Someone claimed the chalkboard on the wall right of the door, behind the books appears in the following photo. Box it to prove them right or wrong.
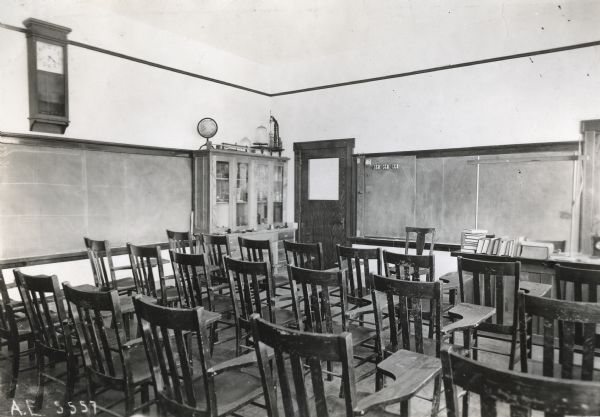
[356,146,578,245]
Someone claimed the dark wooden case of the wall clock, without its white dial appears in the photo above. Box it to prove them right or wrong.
[23,18,71,134]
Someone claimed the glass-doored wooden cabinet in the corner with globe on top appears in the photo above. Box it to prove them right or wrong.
[193,149,294,270]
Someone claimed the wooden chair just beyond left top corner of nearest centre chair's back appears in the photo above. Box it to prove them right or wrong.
[225,256,295,356]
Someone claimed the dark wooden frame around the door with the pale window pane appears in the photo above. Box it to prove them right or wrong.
[294,138,356,242]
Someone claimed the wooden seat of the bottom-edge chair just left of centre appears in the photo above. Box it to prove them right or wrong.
[188,365,263,416]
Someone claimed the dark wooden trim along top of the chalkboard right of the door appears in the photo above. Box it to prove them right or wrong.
[354,141,581,158]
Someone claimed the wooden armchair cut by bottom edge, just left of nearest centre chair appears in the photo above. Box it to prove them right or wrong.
[133,296,262,417]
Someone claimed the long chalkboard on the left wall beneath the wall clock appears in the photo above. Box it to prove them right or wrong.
[0,144,192,259]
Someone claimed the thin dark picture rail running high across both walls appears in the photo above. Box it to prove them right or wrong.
[0,22,600,97]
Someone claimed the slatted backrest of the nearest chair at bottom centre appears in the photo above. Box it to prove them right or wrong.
[252,315,356,417]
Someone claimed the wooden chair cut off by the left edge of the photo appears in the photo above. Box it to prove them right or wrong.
[0,270,34,398]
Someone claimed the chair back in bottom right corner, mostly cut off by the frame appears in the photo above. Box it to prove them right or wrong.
[441,349,600,417]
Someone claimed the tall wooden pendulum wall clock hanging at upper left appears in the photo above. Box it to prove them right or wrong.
[23,19,71,134]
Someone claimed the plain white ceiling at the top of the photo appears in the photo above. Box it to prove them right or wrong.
[85,0,600,65]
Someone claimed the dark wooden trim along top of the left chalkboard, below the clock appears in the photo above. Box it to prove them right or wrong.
[0,131,193,158]
